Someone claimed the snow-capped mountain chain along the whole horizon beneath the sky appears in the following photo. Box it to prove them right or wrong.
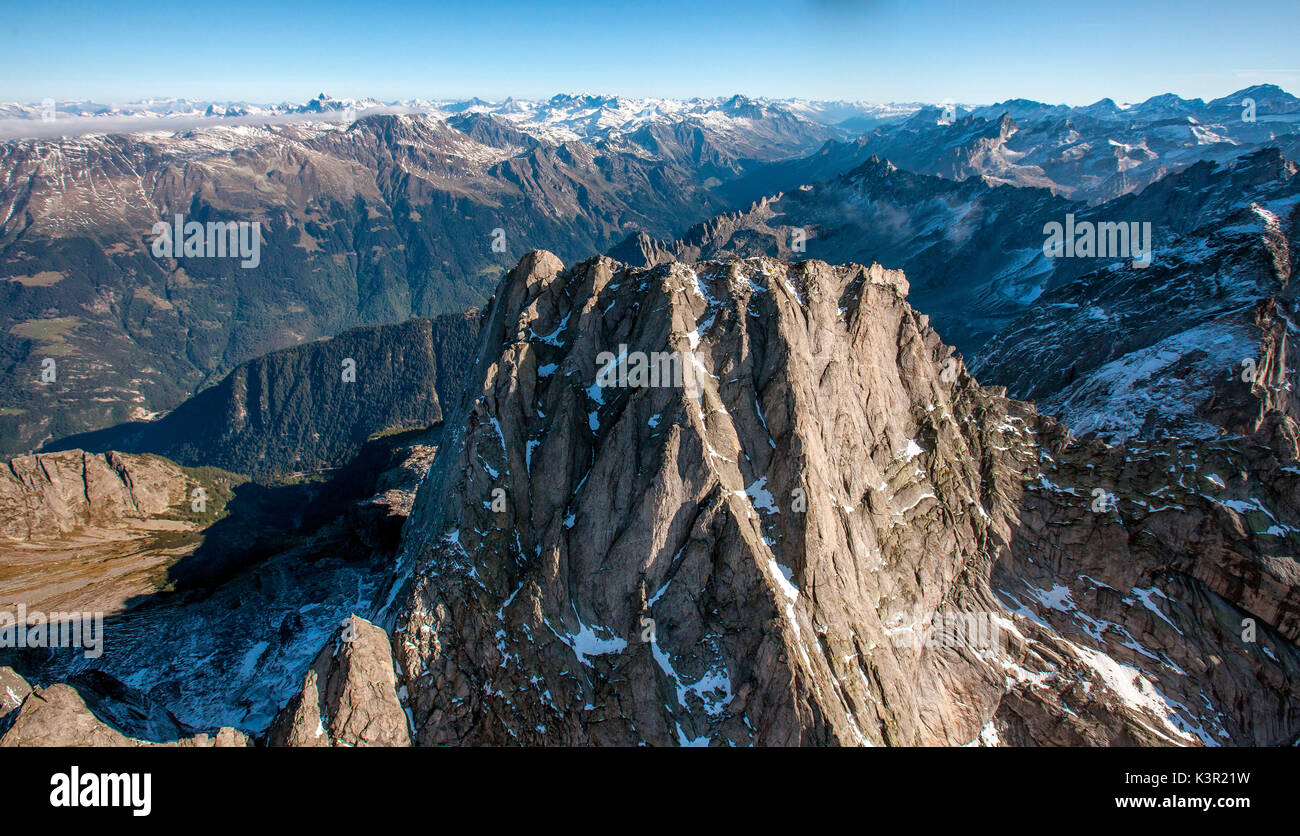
[10,85,1300,205]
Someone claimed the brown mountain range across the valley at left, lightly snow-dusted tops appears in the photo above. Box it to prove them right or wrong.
[0,107,790,452]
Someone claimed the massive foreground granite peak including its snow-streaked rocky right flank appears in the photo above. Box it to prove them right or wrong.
[369,252,1300,745]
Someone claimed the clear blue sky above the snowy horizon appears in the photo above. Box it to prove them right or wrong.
[0,0,1300,104]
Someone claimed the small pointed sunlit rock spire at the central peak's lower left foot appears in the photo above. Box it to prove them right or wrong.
[269,615,411,746]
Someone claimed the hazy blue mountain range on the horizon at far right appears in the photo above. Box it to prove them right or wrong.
[725,85,1300,204]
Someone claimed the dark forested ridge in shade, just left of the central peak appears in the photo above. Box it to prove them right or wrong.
[55,313,478,480]
